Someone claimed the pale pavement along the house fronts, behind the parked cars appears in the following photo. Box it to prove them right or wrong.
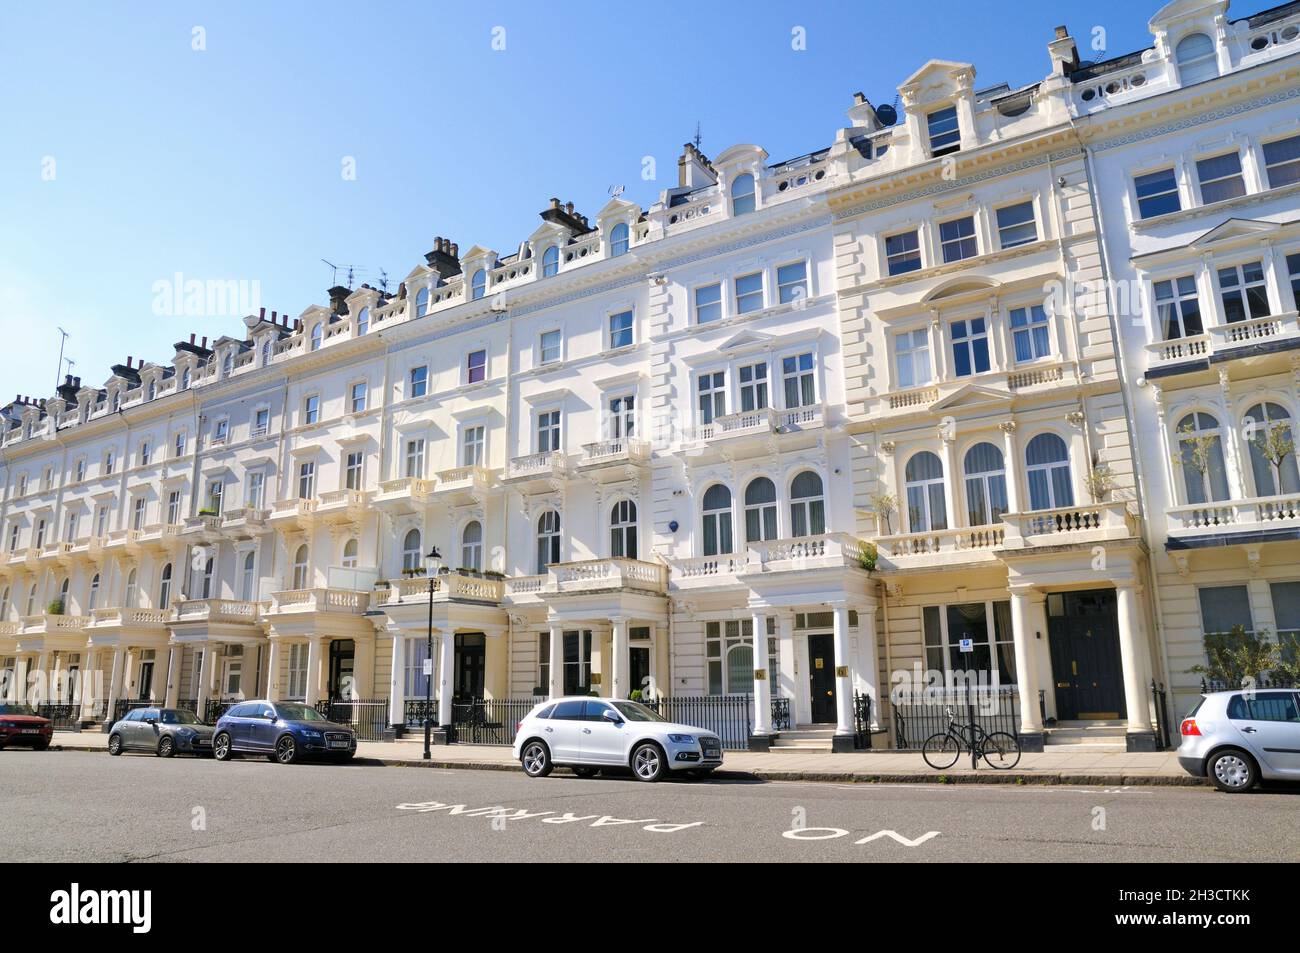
[53,732,1208,787]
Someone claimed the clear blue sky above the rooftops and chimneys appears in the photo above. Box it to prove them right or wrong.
[0,0,1232,402]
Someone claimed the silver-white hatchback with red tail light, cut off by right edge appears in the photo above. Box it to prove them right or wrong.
[1178,689,1300,794]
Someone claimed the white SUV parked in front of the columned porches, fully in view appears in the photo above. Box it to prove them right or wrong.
[515,698,723,781]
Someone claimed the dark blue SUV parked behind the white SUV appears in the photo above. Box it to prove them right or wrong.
[212,701,356,764]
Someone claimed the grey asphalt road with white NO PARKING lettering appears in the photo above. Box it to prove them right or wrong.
[0,750,1300,863]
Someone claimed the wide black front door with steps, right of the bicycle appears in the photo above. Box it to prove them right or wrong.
[1048,589,1126,720]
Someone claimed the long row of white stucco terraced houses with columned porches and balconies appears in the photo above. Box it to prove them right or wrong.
[0,0,1300,750]
